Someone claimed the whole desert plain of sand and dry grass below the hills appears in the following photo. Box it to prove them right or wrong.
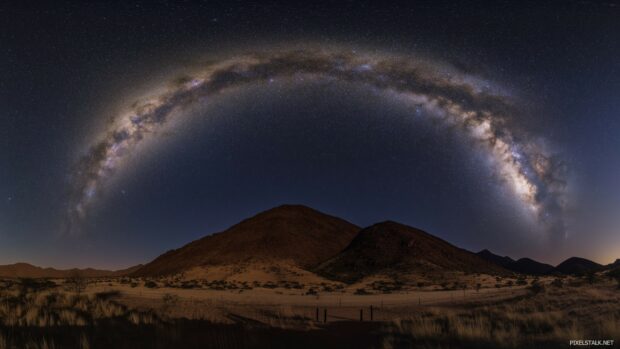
[0,273,620,349]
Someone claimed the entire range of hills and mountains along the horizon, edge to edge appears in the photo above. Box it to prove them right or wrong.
[0,201,608,283]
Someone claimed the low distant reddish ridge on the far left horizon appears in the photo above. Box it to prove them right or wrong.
[0,263,140,278]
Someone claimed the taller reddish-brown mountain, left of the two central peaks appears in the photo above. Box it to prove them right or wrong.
[133,205,360,276]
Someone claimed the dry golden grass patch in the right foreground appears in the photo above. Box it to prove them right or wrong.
[384,287,620,348]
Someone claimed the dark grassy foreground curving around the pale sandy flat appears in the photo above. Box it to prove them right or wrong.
[0,273,620,349]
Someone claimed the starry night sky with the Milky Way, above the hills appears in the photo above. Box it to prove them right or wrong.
[0,1,620,268]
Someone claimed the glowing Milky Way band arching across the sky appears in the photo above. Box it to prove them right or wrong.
[66,50,565,232]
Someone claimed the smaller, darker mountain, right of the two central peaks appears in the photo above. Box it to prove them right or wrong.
[315,221,505,282]
